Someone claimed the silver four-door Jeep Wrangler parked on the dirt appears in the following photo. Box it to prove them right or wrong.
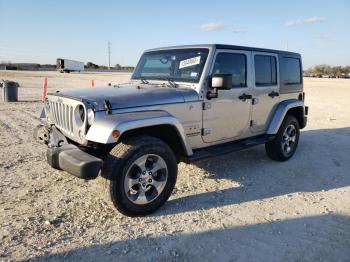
[34,45,308,216]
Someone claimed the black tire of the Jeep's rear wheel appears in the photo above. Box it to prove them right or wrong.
[265,115,300,162]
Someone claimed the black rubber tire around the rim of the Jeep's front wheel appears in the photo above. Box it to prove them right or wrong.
[102,136,177,217]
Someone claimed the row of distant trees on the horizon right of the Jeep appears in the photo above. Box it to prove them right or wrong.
[304,65,350,78]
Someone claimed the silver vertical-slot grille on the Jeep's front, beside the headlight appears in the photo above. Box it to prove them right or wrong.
[49,100,73,135]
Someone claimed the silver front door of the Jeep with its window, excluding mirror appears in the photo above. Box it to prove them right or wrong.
[202,50,252,143]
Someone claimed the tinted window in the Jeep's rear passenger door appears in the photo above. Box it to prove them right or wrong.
[254,55,277,86]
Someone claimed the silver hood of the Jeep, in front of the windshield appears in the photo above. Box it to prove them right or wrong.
[52,85,199,110]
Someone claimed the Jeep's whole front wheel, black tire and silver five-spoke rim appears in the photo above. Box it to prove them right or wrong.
[102,136,177,216]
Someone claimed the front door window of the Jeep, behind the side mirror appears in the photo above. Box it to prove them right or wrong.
[213,53,247,87]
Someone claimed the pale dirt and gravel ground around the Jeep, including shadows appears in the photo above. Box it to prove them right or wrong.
[0,71,350,261]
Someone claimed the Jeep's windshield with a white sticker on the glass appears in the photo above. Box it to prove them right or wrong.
[132,48,209,83]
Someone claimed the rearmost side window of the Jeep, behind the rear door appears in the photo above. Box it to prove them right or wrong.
[281,57,301,85]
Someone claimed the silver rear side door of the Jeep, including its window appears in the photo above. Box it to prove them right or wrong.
[250,52,279,133]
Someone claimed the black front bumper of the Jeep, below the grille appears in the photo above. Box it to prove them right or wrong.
[46,144,103,179]
